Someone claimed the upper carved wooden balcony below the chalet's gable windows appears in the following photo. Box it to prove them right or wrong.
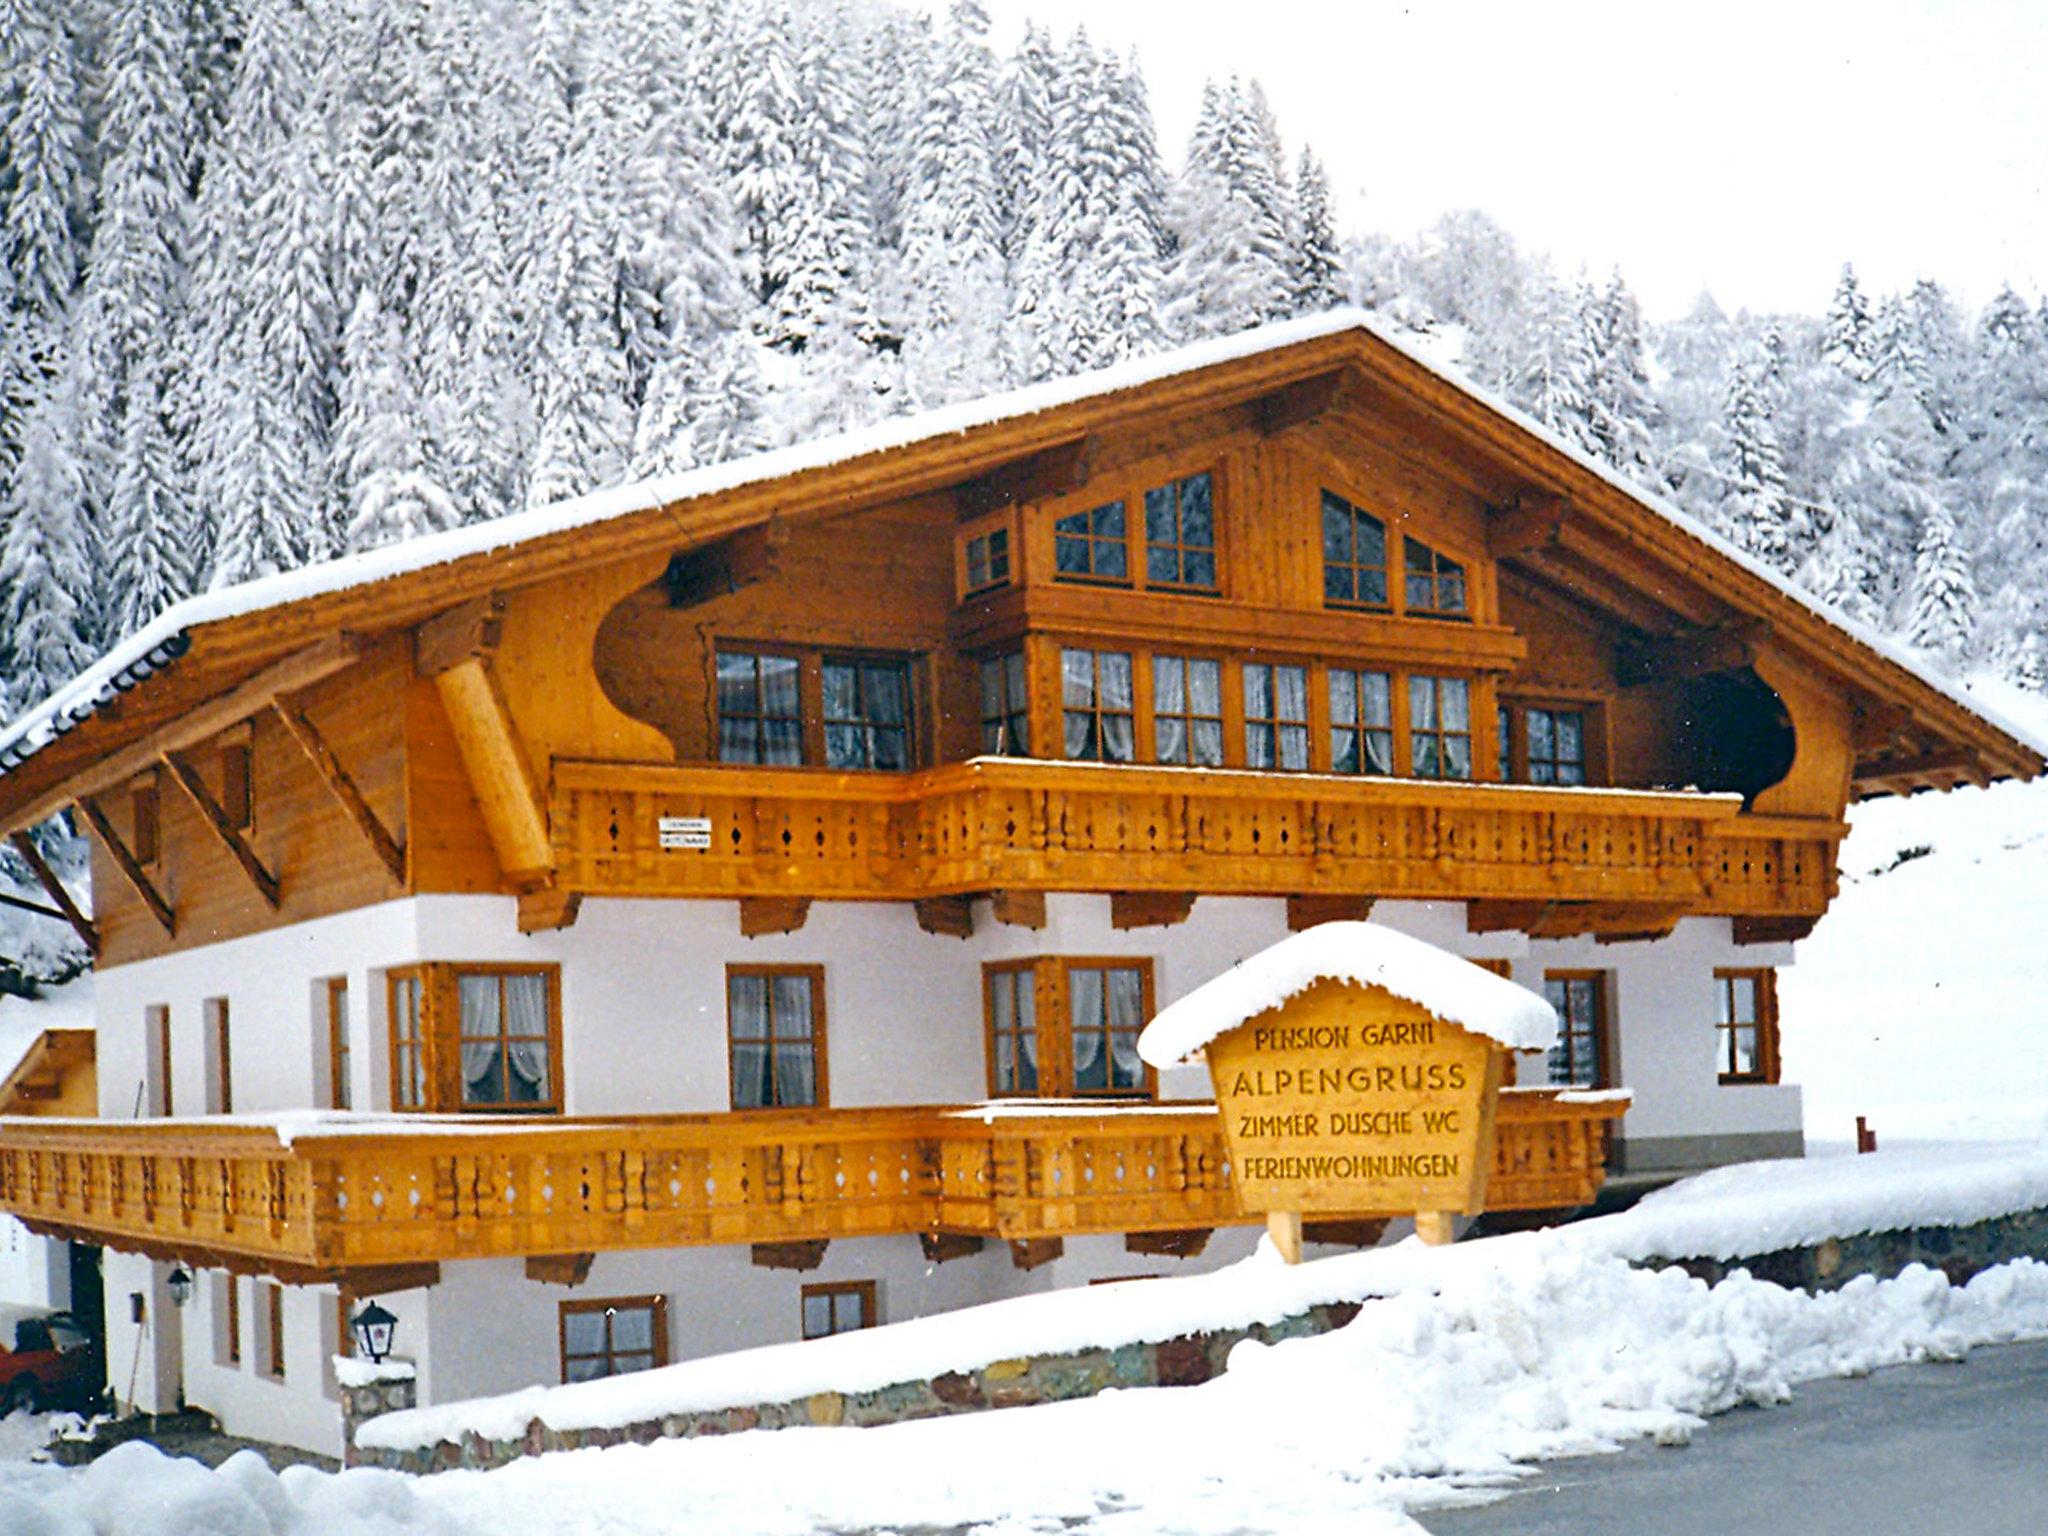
[549,758,1845,915]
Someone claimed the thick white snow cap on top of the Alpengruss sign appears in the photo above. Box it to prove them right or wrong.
[1139,922,1556,1067]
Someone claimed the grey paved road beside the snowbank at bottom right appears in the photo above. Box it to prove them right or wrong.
[1417,1343,2048,1536]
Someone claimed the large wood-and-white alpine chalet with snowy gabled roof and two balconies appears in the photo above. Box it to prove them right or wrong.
[0,315,2042,1452]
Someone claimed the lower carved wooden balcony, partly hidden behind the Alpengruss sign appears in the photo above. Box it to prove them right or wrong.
[0,1090,1628,1282]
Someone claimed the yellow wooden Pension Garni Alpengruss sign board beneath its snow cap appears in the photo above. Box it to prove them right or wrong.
[1208,981,1503,1249]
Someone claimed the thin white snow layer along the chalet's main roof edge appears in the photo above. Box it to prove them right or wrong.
[0,309,2048,794]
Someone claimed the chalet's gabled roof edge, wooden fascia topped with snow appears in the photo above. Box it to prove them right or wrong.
[0,309,2048,843]
